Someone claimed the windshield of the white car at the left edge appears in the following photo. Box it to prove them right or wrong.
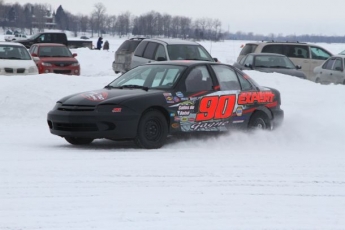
[0,45,31,60]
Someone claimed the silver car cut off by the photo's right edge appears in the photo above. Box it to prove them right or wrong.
[312,54,345,85]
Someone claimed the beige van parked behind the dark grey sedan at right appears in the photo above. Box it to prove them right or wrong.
[237,41,333,80]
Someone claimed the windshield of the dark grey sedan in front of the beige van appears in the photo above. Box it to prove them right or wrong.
[254,55,296,69]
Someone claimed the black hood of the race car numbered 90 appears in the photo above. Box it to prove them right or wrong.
[59,88,165,106]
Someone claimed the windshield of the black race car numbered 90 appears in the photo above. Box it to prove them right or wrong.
[107,64,186,89]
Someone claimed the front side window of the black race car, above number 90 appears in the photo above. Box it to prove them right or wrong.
[185,66,213,92]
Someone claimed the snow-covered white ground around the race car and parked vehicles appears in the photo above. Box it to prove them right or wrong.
[0,36,345,230]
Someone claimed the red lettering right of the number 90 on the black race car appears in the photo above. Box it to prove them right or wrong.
[237,91,274,105]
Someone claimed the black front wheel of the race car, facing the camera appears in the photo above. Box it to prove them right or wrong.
[134,110,168,149]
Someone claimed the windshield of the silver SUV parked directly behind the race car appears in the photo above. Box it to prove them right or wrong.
[167,44,214,61]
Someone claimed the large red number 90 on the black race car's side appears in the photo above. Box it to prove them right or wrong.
[195,94,236,121]
